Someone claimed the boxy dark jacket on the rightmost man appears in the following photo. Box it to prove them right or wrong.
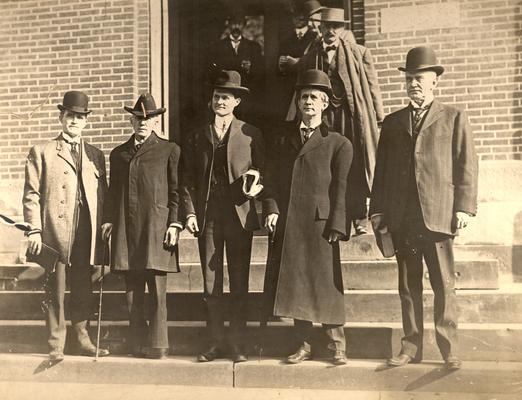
[370,100,478,235]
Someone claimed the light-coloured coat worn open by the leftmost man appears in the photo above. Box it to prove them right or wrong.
[23,135,107,265]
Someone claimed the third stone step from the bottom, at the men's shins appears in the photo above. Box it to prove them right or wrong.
[0,284,522,323]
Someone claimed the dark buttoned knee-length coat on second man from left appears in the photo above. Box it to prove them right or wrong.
[104,132,180,272]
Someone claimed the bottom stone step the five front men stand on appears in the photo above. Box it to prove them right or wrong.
[0,354,522,399]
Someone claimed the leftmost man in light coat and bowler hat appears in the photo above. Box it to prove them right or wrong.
[23,91,109,361]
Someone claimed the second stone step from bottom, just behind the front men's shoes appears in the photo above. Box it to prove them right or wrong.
[0,321,522,362]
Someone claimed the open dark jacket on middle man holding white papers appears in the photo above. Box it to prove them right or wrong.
[181,118,265,232]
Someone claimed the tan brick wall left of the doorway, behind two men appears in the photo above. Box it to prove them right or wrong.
[0,0,149,187]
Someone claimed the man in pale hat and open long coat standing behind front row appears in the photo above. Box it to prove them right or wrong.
[287,8,384,235]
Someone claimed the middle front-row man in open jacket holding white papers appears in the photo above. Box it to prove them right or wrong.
[181,71,265,362]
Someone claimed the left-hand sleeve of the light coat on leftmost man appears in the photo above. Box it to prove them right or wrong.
[22,146,42,230]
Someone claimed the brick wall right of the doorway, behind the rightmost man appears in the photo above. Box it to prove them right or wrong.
[364,0,522,160]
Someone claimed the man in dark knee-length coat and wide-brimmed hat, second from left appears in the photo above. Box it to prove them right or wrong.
[102,93,182,359]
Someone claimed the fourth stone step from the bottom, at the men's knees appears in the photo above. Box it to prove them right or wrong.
[0,259,499,292]
